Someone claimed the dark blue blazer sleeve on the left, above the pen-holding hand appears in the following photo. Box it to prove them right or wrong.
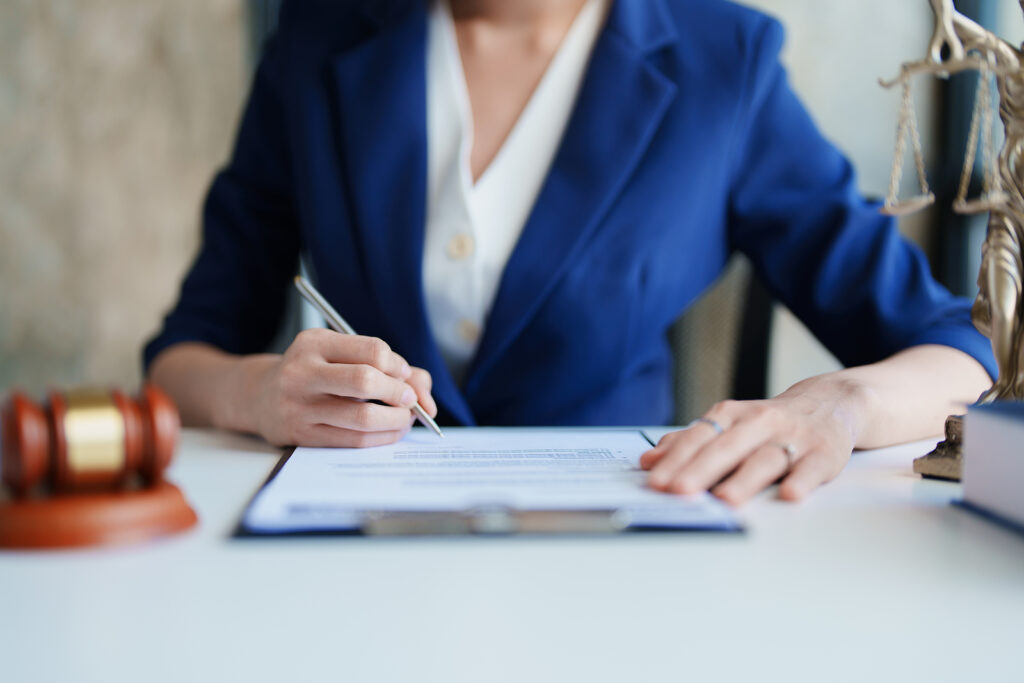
[143,17,299,368]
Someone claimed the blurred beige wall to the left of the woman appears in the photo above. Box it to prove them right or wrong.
[0,0,247,391]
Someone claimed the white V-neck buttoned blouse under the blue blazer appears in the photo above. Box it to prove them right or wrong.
[423,0,609,383]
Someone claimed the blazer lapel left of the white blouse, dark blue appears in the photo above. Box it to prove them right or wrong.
[333,3,473,424]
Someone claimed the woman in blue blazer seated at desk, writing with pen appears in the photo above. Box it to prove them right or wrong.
[145,0,991,504]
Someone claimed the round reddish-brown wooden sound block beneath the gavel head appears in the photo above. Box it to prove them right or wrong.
[0,481,199,550]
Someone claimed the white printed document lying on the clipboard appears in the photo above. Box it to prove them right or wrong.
[243,428,738,533]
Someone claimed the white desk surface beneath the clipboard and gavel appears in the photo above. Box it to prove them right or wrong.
[0,431,1024,683]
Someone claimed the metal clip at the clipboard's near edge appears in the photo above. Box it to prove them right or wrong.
[361,505,630,536]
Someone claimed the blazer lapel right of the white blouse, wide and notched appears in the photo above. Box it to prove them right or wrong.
[465,0,676,397]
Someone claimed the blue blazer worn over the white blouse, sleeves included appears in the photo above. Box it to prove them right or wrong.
[145,0,993,425]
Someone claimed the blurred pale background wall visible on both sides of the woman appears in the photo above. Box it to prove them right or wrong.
[0,0,1024,400]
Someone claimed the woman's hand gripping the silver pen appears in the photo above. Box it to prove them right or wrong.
[245,329,437,447]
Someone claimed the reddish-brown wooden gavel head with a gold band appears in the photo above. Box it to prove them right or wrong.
[0,385,180,497]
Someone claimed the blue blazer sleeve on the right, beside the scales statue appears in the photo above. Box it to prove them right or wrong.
[729,19,996,377]
